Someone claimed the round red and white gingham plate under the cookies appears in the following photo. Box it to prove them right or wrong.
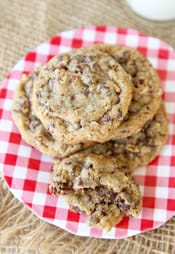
[0,26,175,238]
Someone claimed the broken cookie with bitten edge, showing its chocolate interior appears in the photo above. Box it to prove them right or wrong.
[49,153,142,232]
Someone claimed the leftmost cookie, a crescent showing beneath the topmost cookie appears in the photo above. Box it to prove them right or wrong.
[12,68,93,157]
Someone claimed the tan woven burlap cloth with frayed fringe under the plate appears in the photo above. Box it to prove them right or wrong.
[0,0,175,254]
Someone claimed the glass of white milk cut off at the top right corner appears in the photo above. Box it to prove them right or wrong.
[126,0,175,21]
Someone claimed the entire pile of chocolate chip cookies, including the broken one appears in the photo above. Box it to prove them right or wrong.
[12,44,168,231]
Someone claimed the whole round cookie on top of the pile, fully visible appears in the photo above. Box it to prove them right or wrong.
[32,47,132,144]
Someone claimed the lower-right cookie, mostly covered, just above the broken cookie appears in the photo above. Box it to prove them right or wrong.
[84,101,168,170]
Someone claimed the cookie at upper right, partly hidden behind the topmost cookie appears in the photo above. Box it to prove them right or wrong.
[92,44,162,139]
